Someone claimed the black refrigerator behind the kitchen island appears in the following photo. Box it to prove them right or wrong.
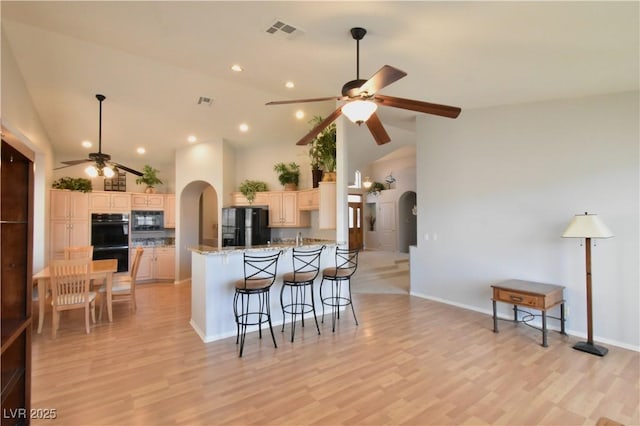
[222,207,271,247]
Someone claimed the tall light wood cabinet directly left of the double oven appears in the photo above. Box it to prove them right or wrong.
[49,189,91,259]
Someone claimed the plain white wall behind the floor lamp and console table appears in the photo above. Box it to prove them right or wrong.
[411,92,640,350]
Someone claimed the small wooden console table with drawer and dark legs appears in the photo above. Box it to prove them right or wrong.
[491,280,566,348]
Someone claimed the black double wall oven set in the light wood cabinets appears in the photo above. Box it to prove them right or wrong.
[91,213,129,272]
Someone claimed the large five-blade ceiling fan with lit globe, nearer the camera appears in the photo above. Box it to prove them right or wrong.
[267,27,461,145]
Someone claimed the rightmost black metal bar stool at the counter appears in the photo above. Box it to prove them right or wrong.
[320,247,358,333]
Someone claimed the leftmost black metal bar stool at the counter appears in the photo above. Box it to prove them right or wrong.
[233,252,281,357]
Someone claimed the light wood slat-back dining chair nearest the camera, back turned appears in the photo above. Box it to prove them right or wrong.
[51,258,96,339]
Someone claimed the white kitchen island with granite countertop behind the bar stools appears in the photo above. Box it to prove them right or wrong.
[189,239,338,342]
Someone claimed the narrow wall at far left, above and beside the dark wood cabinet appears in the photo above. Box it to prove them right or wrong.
[0,31,53,272]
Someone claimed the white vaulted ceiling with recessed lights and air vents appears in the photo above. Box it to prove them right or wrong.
[1,1,640,171]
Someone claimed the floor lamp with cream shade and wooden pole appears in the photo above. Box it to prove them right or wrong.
[562,212,613,356]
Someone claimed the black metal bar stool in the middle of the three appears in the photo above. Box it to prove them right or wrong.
[280,246,324,342]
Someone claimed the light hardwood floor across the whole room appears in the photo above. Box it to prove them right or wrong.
[32,284,640,425]
